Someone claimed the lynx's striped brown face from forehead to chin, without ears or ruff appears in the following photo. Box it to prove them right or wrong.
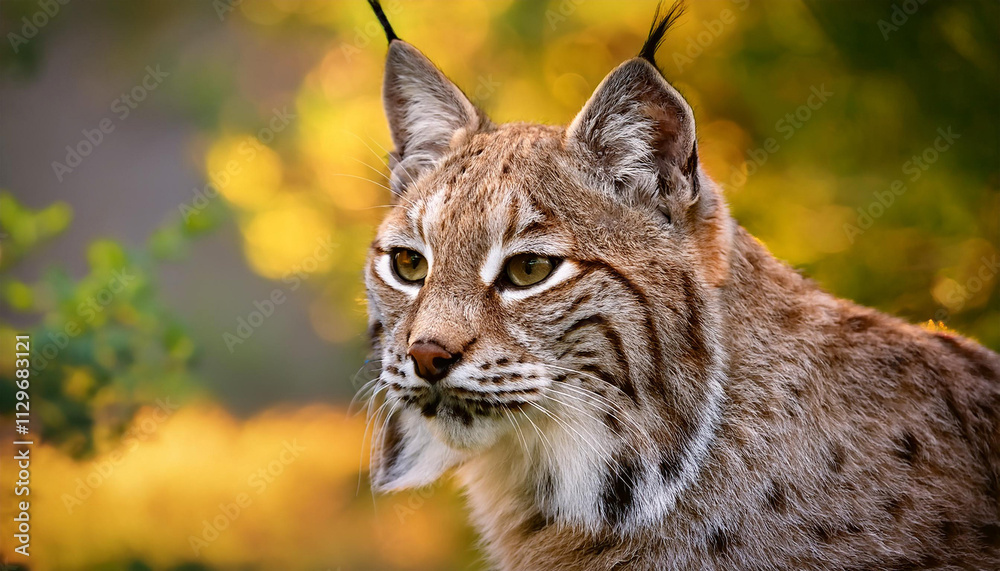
[368,125,704,470]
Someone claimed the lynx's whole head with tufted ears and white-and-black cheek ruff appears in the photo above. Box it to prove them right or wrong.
[366,1,730,524]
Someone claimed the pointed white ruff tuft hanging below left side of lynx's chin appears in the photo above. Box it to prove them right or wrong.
[371,410,464,492]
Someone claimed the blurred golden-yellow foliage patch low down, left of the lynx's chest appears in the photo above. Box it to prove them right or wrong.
[0,402,465,571]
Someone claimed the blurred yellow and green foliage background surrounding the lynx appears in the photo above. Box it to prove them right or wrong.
[0,0,1000,570]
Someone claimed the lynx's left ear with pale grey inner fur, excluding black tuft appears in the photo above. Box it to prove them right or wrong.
[382,39,489,194]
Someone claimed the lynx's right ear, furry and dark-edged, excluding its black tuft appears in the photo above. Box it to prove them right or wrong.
[567,58,699,218]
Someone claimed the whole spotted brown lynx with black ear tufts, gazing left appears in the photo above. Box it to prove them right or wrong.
[365,0,1000,571]
